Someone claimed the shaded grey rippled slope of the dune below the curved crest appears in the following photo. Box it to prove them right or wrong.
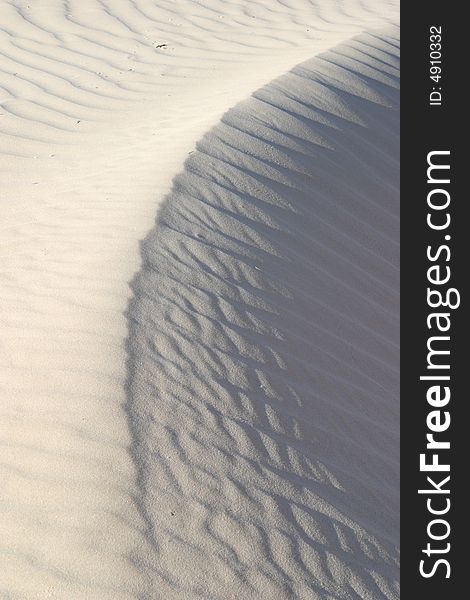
[127,28,399,600]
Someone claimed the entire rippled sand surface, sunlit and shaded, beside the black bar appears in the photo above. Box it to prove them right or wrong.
[0,0,398,600]
